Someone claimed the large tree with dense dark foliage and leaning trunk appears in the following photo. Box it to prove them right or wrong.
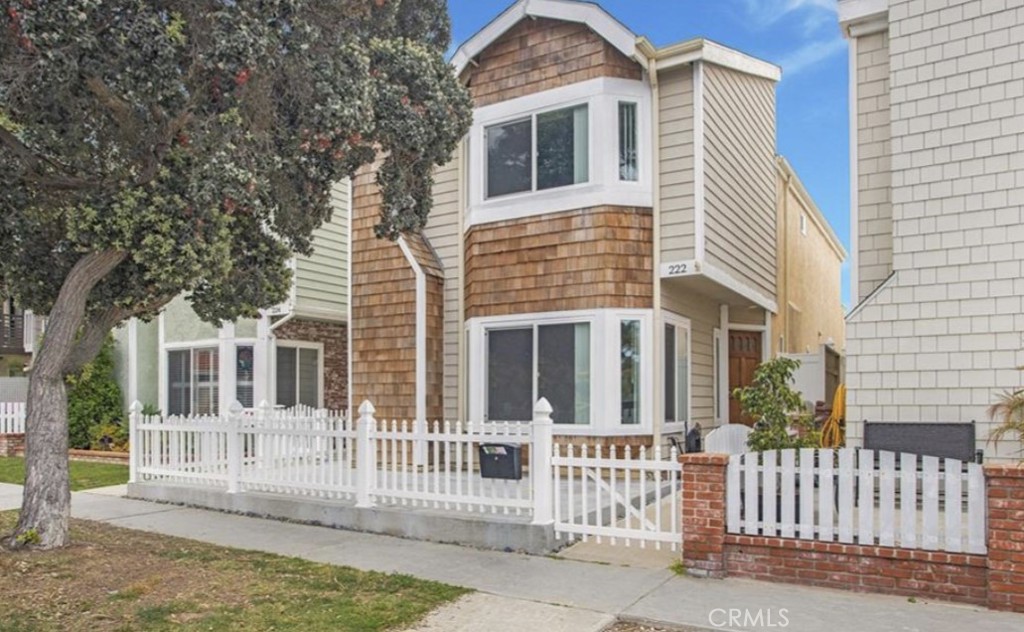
[0,0,471,548]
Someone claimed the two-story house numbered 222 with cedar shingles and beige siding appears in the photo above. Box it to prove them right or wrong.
[351,0,843,445]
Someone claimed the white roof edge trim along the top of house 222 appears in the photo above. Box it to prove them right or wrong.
[452,0,782,81]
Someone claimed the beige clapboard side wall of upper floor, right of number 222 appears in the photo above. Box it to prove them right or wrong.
[703,64,776,296]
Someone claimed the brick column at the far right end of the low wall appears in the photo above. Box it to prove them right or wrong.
[985,465,1024,613]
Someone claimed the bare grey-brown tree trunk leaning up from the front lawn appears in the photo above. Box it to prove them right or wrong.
[5,251,125,549]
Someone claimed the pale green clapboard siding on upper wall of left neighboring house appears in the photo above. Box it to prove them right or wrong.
[295,180,349,319]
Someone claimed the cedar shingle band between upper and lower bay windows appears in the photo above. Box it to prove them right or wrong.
[466,206,652,319]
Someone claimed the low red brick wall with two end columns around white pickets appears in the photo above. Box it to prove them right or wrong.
[679,454,1024,613]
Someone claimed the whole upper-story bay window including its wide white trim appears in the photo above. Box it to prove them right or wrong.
[466,77,653,225]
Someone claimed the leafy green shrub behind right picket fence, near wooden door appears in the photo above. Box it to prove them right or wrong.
[732,357,821,452]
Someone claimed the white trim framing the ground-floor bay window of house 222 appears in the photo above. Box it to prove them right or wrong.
[466,309,654,436]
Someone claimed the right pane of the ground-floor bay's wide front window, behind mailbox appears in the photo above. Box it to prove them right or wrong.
[537,323,590,424]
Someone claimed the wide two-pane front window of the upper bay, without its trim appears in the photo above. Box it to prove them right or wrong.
[486,106,590,198]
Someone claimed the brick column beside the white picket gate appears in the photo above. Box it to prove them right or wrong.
[679,454,729,578]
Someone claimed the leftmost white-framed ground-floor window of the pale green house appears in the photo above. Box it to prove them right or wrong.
[167,347,220,415]
